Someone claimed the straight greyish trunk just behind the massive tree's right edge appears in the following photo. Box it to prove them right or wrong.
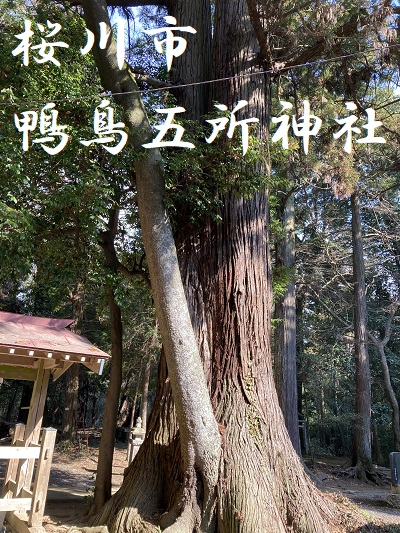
[274,193,301,456]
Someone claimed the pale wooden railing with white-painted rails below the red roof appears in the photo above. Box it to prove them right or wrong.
[0,424,57,531]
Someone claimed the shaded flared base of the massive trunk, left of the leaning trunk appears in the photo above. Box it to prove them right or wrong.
[94,354,183,533]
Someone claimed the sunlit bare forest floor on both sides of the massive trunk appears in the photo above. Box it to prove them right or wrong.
[0,436,400,533]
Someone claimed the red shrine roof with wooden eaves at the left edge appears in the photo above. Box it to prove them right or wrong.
[0,311,110,378]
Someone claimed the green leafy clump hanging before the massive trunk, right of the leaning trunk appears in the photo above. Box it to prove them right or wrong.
[164,112,268,227]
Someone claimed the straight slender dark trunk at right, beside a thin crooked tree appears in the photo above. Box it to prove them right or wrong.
[351,191,372,479]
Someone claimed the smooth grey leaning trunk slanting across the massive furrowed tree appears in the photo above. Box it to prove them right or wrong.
[82,0,221,533]
